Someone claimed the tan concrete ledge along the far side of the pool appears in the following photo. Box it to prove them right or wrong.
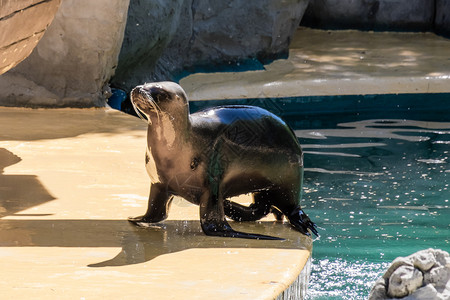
[180,28,450,100]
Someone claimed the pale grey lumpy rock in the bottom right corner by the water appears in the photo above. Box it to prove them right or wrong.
[369,249,450,300]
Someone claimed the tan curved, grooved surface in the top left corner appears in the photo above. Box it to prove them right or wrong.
[0,0,60,75]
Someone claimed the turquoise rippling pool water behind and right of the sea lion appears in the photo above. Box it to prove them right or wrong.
[190,94,450,300]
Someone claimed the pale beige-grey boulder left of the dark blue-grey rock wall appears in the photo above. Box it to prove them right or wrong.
[0,0,128,106]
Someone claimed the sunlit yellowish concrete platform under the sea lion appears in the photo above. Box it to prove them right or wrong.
[0,108,312,299]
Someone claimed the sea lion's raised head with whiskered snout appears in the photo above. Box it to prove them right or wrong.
[131,81,188,123]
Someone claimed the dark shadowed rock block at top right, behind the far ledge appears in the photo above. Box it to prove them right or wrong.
[302,0,434,31]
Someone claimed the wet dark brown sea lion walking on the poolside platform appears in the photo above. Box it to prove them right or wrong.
[129,82,318,239]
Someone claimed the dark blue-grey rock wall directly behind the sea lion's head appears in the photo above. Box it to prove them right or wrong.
[113,0,309,89]
